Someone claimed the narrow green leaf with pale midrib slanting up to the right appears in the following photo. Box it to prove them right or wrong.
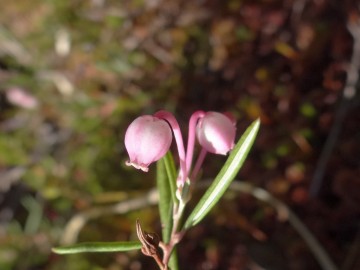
[184,119,260,229]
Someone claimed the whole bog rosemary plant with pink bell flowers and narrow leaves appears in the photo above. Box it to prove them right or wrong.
[53,111,260,270]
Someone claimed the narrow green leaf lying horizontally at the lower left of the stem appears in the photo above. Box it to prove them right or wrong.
[52,241,142,254]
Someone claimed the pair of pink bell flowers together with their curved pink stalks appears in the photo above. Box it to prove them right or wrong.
[125,111,236,185]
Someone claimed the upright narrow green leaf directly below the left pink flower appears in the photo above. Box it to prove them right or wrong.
[156,154,172,243]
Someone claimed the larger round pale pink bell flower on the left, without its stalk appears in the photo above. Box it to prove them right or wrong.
[125,115,172,172]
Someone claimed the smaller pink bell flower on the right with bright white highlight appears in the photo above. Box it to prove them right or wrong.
[196,112,236,155]
